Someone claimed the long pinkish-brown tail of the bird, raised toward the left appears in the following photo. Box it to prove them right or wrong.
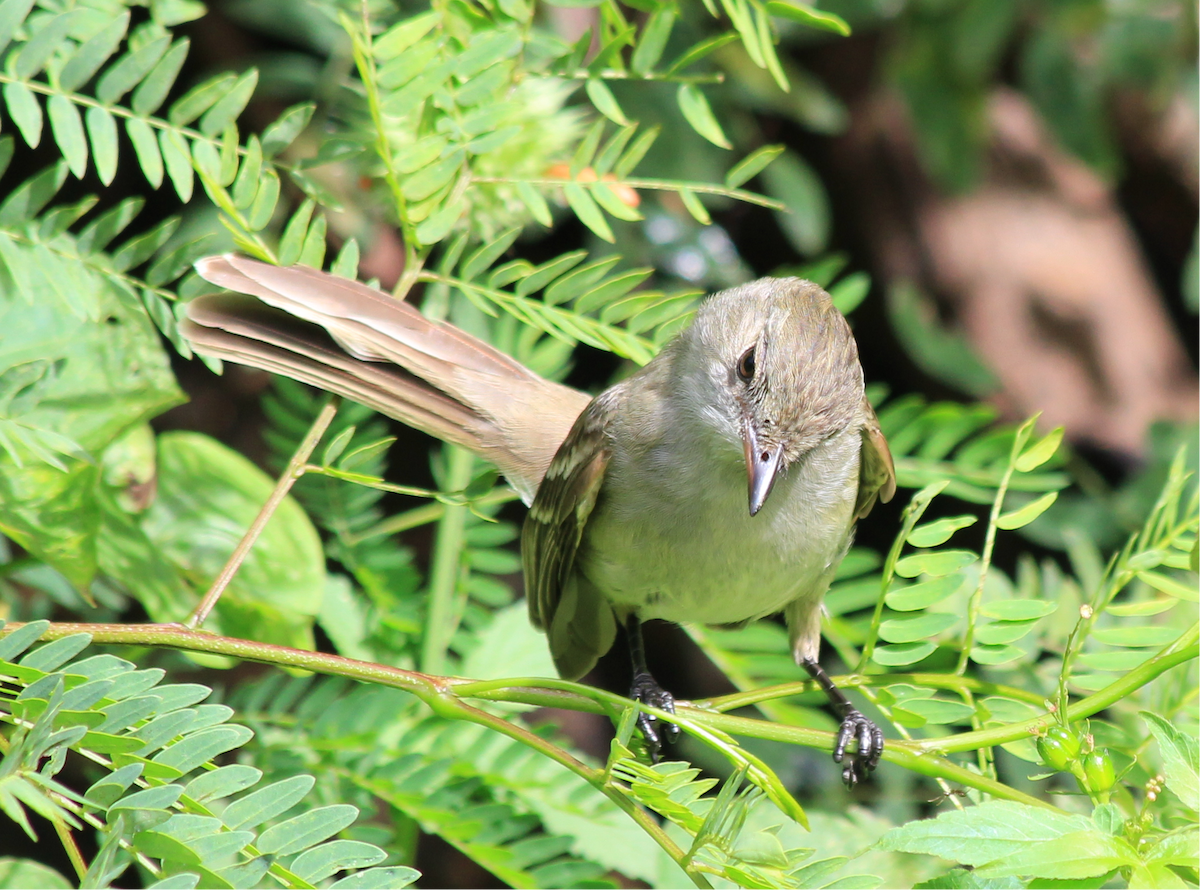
[181,254,588,503]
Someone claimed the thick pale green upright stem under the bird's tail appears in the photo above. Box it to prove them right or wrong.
[421,445,475,674]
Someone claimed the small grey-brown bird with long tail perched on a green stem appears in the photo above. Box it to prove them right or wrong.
[182,255,895,784]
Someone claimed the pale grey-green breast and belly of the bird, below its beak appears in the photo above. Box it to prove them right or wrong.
[576,431,859,624]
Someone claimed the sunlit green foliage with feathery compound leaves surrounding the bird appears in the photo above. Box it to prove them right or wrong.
[0,0,1200,890]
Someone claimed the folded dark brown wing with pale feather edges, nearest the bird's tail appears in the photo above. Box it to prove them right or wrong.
[521,395,613,660]
